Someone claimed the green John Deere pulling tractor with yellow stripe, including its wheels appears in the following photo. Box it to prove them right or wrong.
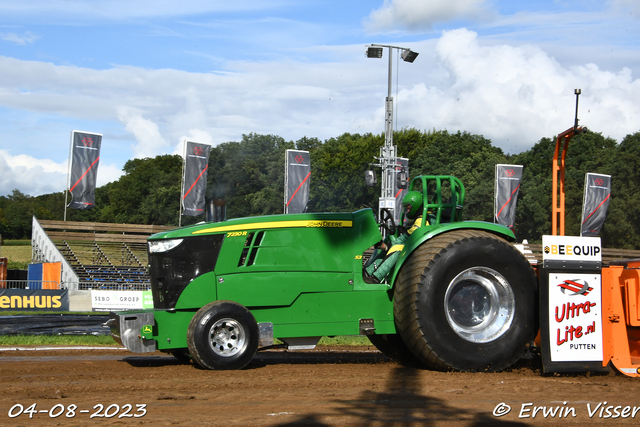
[109,176,538,371]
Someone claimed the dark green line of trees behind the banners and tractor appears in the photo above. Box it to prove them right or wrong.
[0,129,640,249]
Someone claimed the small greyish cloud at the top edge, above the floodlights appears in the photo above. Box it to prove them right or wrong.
[365,0,490,32]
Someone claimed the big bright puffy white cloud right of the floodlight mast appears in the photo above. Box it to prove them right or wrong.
[402,29,640,153]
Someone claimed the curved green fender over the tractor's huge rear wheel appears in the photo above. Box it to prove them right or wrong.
[388,221,516,288]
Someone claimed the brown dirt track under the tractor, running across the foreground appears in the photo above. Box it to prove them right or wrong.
[0,347,640,426]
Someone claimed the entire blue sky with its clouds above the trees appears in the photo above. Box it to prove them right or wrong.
[0,0,640,195]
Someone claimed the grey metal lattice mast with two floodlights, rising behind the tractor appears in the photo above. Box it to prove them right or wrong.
[366,44,418,218]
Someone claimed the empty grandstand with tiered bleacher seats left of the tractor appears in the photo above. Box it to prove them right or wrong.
[33,220,174,290]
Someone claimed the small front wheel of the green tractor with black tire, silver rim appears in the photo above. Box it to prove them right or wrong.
[187,301,260,370]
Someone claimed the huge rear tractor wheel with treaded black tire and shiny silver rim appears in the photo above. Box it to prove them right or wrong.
[394,230,538,371]
